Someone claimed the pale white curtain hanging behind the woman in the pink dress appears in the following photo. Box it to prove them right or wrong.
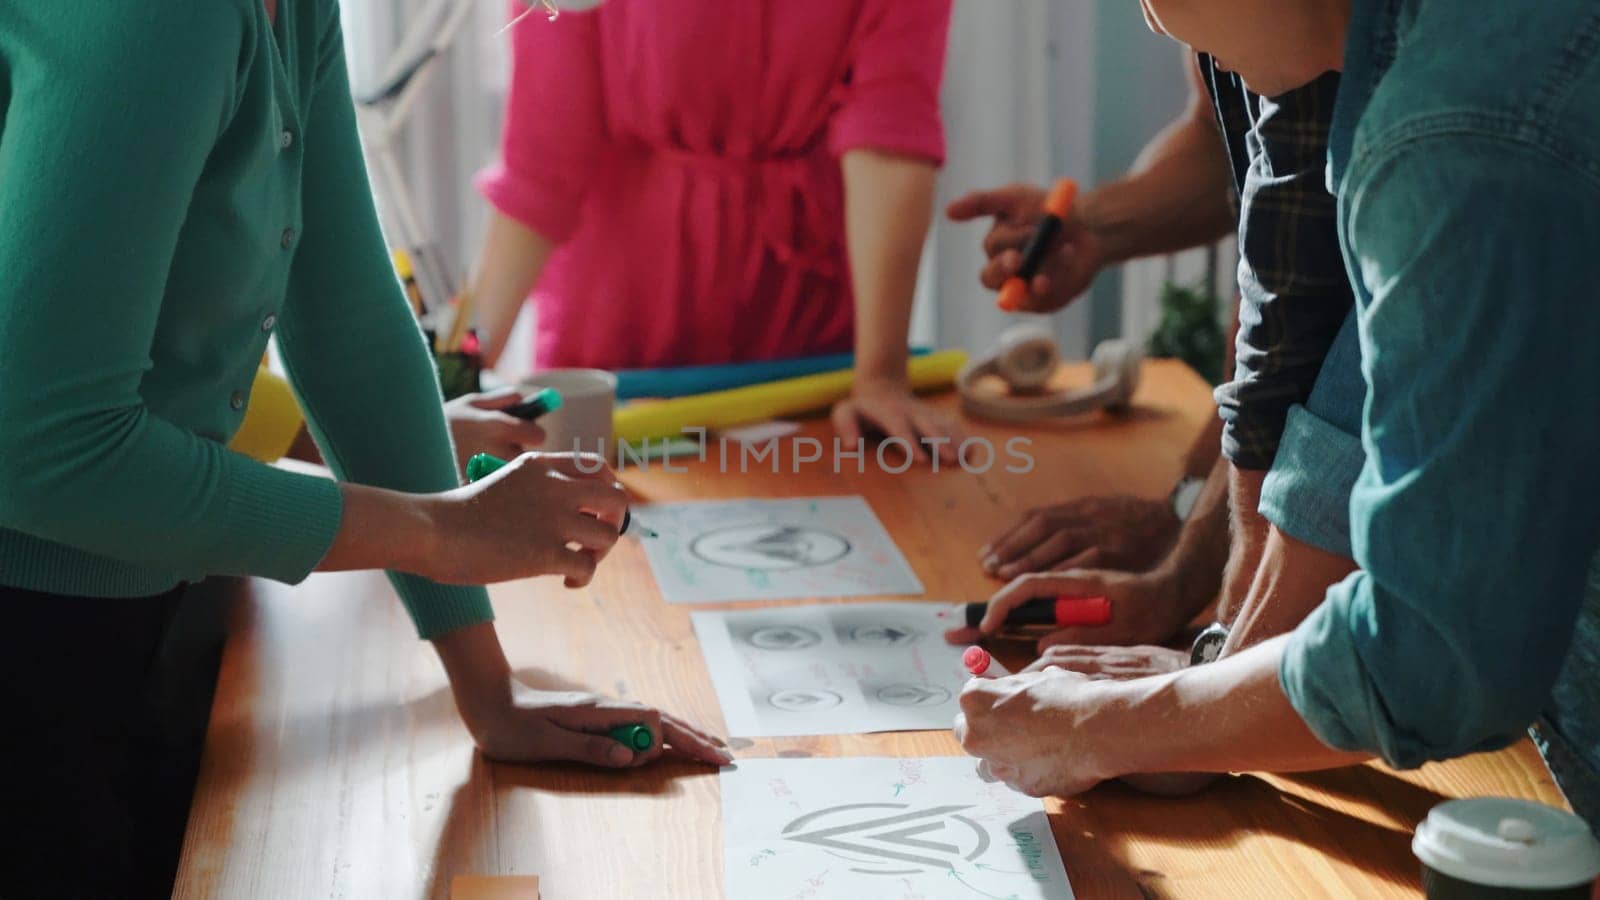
[341,0,1209,367]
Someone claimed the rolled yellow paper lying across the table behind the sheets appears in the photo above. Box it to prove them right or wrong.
[611,351,966,445]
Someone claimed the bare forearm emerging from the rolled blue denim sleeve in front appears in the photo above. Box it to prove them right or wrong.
[1091,637,1371,778]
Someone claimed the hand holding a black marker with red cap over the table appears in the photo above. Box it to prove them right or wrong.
[944,569,1190,653]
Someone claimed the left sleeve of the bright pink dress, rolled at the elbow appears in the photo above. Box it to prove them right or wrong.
[475,0,605,243]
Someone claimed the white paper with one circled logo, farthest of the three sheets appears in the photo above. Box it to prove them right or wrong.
[634,496,922,604]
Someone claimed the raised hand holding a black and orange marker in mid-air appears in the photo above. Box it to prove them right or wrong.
[946,184,1106,312]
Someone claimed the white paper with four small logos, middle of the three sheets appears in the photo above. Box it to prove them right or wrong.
[690,602,971,737]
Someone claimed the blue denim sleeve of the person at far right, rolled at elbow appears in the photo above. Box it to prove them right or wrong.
[1280,131,1600,767]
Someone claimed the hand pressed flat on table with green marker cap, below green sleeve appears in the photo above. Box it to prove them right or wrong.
[434,623,733,769]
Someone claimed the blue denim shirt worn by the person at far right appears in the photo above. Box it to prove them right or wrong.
[1262,0,1600,825]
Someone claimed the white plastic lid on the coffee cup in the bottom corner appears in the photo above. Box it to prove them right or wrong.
[1411,798,1600,889]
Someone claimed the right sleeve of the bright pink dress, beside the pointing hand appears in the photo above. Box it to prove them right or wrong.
[829,0,950,163]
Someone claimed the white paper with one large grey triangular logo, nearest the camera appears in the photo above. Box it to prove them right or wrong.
[722,756,1072,900]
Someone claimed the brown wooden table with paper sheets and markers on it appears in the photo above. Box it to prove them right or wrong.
[176,362,1562,900]
